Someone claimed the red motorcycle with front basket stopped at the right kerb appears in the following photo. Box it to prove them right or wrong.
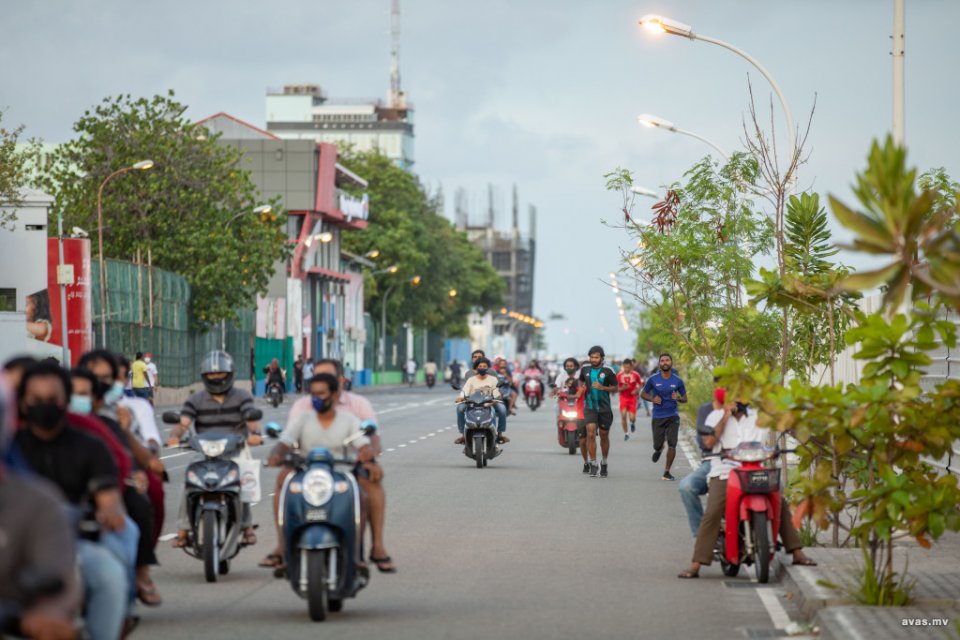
[714,442,781,584]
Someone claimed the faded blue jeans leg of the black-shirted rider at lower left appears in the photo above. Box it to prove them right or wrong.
[77,540,131,640]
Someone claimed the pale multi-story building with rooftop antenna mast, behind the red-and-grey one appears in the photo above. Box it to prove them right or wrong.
[267,84,413,169]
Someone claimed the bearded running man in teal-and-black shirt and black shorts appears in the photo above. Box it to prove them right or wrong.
[577,346,617,478]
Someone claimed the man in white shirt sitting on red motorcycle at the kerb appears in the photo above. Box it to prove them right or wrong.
[677,402,816,578]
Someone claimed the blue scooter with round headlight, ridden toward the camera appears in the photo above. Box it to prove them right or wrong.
[267,421,376,622]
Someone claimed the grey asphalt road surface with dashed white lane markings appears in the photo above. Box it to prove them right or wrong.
[136,388,808,640]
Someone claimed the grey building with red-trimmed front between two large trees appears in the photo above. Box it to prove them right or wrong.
[198,113,368,369]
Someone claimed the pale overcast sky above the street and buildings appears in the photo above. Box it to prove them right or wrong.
[0,0,960,354]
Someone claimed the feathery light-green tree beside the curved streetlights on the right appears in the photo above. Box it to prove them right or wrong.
[605,153,780,369]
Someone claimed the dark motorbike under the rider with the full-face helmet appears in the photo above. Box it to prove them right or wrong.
[163,409,263,582]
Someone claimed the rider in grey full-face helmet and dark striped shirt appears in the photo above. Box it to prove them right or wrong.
[167,351,262,547]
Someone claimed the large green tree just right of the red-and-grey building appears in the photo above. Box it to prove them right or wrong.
[340,149,504,336]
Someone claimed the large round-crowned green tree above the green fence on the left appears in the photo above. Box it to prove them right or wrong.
[41,92,289,326]
